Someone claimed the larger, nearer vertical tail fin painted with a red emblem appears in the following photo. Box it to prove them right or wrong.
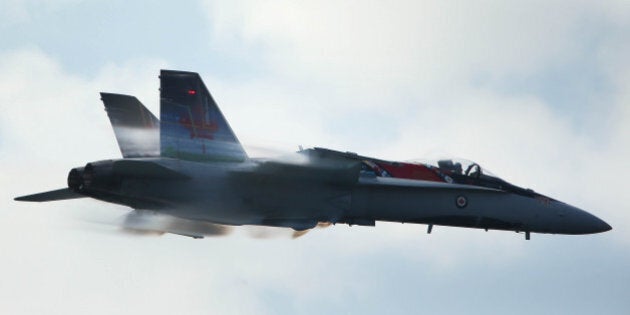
[160,70,247,162]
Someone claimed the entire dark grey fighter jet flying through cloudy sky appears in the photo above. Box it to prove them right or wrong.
[15,70,611,239]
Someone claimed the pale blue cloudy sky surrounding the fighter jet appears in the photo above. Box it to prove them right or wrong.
[0,0,630,314]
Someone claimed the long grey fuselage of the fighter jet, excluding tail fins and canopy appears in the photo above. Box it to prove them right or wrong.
[68,158,610,234]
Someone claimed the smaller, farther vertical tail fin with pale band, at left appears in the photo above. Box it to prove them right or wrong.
[101,93,160,158]
